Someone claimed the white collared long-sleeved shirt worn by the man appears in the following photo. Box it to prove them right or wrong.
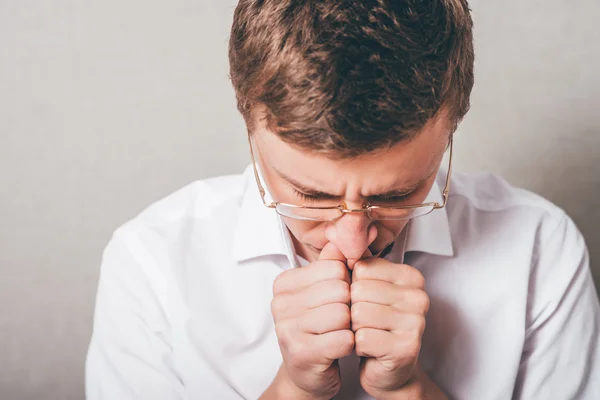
[86,164,600,400]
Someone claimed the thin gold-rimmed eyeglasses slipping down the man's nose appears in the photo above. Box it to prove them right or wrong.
[248,132,454,221]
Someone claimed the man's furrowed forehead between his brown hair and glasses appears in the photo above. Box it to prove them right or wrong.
[253,115,448,193]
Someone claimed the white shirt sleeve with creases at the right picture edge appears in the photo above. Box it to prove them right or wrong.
[513,215,600,400]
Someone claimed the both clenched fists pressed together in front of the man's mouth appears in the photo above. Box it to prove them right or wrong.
[263,243,446,400]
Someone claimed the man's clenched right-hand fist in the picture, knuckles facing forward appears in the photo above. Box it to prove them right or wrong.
[351,258,429,399]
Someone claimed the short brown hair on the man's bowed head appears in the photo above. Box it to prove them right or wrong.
[229,0,474,157]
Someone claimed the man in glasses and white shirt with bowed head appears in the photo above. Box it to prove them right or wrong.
[87,0,600,400]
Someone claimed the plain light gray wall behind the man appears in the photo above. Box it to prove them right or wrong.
[0,0,600,399]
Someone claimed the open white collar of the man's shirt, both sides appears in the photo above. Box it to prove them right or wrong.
[233,165,454,266]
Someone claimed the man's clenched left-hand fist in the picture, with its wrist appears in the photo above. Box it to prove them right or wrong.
[264,244,354,399]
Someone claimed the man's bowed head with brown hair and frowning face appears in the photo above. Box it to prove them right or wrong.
[229,0,473,266]
